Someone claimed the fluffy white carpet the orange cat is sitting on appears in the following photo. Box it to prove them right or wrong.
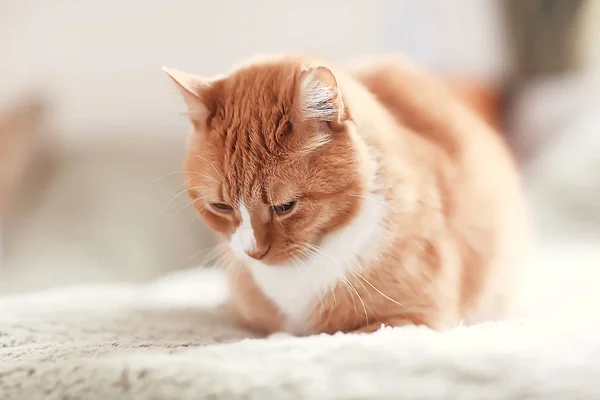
[0,271,600,400]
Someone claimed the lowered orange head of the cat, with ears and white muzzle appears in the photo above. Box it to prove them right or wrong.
[167,62,363,265]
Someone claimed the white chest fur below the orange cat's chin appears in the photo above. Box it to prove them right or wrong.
[238,194,385,335]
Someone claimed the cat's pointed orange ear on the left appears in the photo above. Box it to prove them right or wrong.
[163,67,213,130]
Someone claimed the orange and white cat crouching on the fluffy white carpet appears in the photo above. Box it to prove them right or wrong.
[164,55,528,336]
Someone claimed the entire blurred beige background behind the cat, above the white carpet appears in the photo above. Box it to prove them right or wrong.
[0,0,600,306]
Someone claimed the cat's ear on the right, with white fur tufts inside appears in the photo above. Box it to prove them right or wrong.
[300,67,347,124]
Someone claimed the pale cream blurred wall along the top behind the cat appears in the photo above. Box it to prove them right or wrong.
[0,0,508,139]
